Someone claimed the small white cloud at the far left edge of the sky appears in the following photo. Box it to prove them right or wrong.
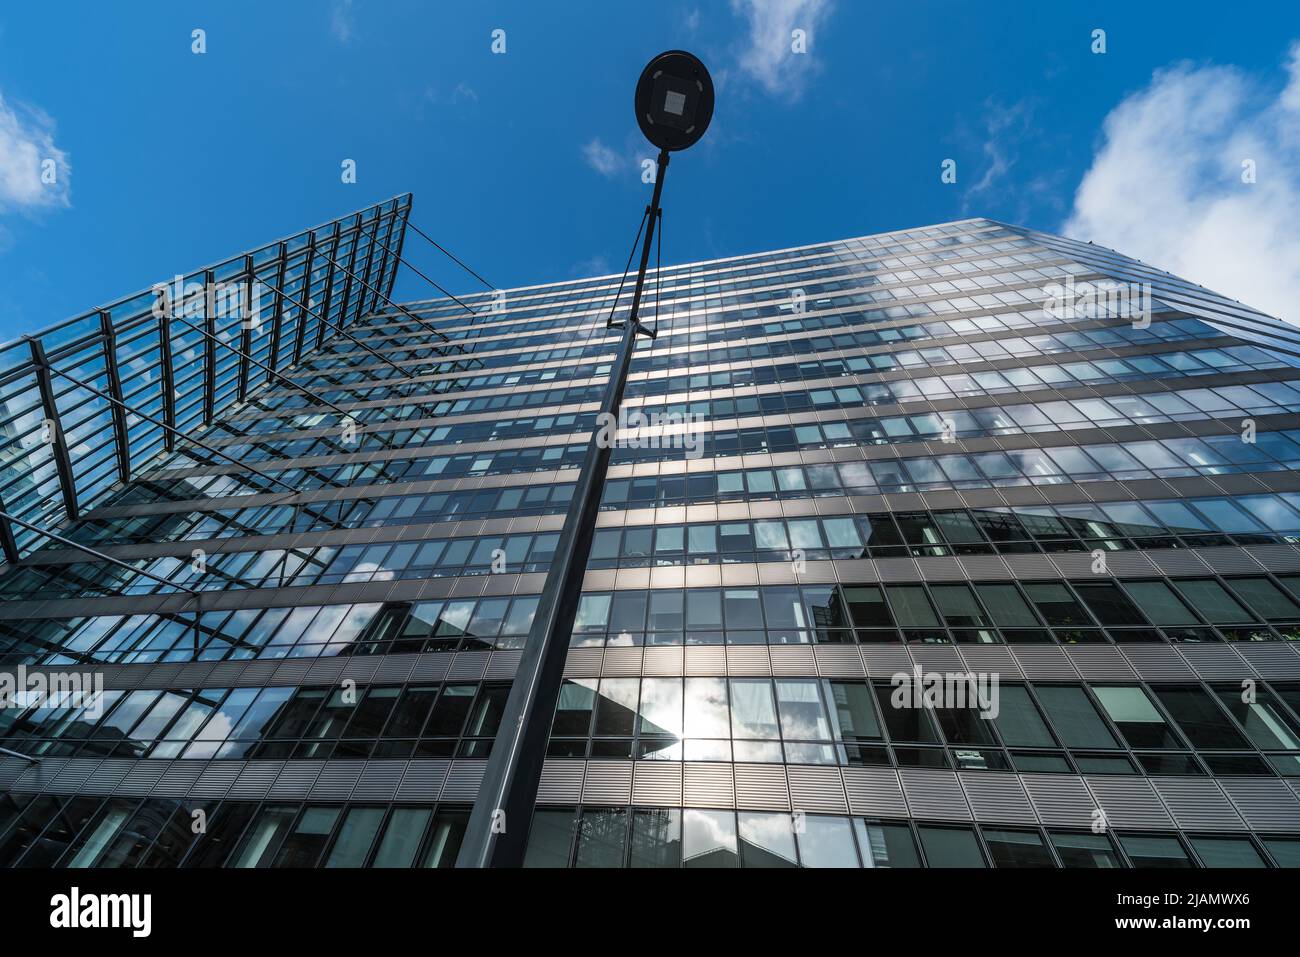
[0,94,72,212]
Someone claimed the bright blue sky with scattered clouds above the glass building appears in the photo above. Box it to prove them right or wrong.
[0,0,1300,339]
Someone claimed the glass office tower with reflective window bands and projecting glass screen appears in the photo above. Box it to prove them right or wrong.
[0,196,1300,867]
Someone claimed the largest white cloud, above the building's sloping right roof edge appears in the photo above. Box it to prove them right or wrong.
[1062,42,1300,324]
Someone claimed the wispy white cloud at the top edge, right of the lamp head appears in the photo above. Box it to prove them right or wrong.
[732,0,831,100]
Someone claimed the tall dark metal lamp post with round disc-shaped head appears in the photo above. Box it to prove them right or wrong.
[456,51,714,867]
